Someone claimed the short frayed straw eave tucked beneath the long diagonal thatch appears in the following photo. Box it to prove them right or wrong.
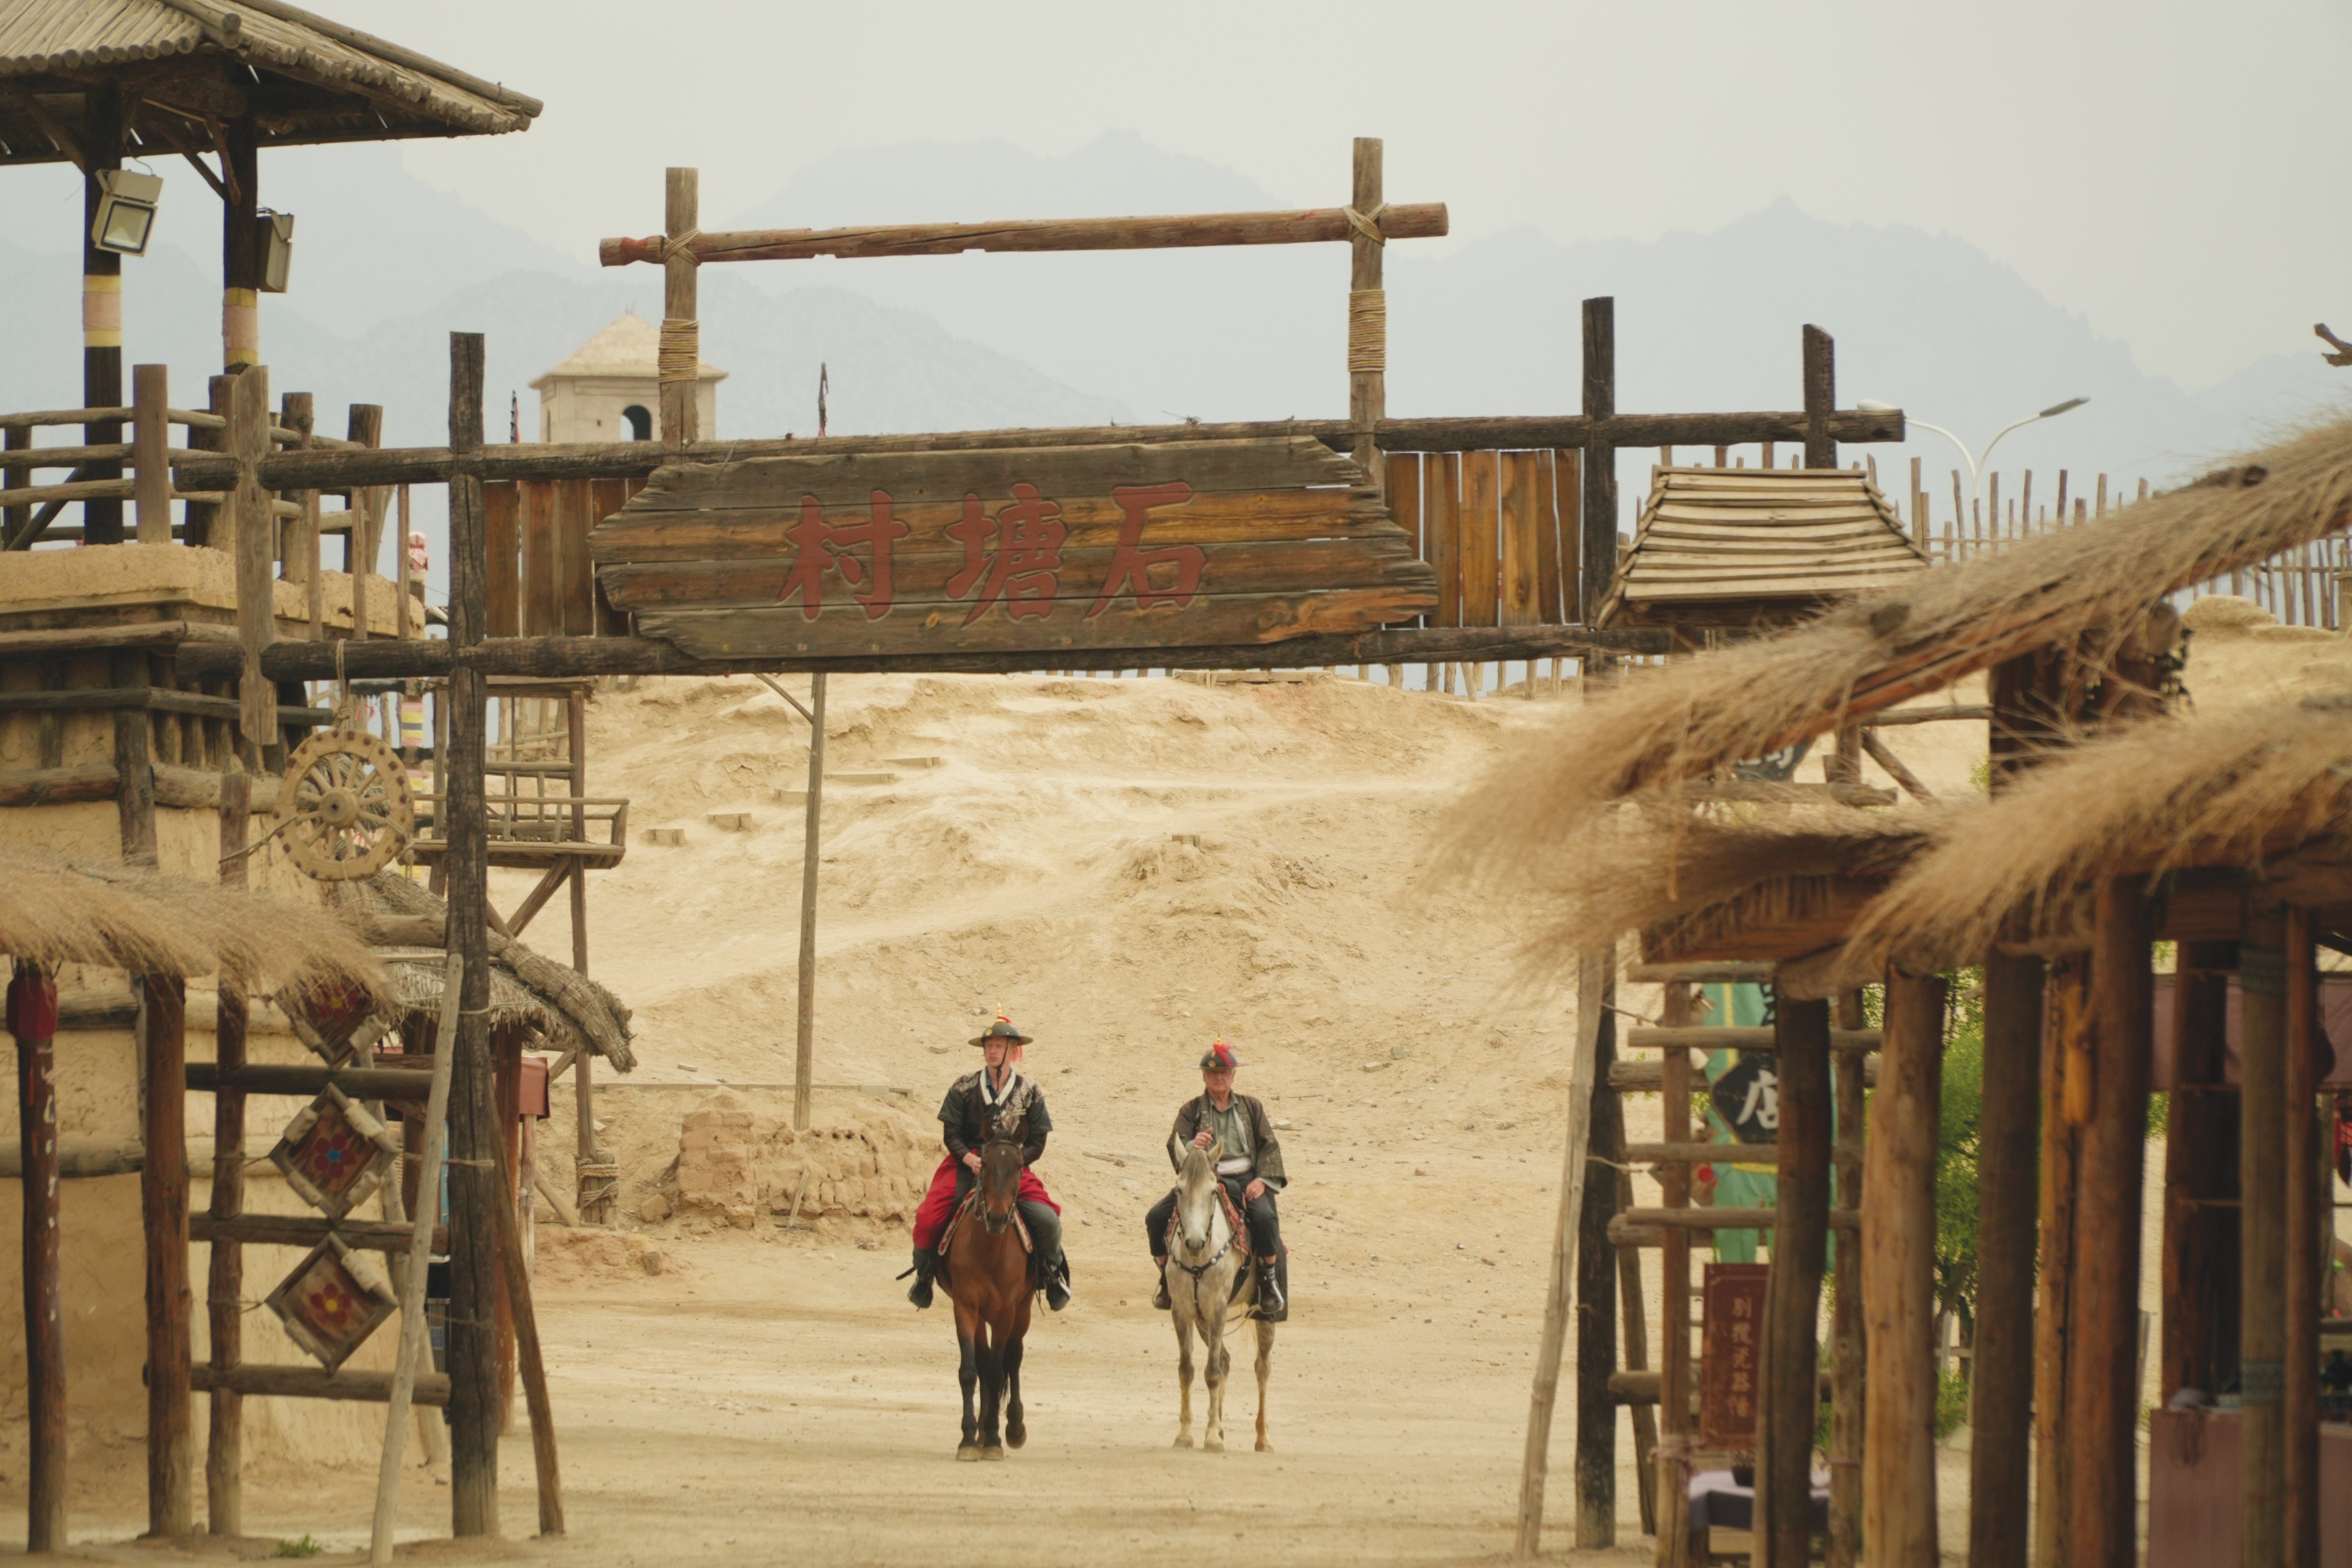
[1486,806,1929,973]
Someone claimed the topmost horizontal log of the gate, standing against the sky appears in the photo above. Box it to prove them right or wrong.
[595,202,1447,265]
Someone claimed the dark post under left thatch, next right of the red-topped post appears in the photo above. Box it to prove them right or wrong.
[139,976,195,1540]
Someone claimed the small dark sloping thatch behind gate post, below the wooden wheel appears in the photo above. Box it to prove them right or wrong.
[339,872,637,1072]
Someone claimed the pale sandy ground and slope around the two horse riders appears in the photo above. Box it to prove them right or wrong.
[0,597,2352,1566]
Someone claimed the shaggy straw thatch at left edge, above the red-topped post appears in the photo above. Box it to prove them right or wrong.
[0,849,386,997]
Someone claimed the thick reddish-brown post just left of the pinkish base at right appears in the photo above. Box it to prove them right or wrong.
[2063,877,2154,1568]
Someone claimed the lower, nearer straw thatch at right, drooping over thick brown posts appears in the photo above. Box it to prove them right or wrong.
[1837,698,2352,983]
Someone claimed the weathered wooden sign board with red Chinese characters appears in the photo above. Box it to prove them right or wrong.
[588,437,1437,658]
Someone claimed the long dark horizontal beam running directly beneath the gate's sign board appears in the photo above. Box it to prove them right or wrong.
[179,625,1667,680]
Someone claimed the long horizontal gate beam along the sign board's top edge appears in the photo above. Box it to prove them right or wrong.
[172,409,1903,491]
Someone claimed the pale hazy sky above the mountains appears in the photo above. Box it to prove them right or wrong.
[327,0,2352,390]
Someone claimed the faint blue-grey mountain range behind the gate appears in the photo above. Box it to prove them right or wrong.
[0,134,2352,592]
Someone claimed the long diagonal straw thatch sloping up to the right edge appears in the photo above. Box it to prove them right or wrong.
[1456,419,2352,879]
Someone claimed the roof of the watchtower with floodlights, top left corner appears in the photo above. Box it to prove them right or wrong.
[0,0,541,162]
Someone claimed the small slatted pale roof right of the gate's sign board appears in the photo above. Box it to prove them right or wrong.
[1599,468,1926,628]
